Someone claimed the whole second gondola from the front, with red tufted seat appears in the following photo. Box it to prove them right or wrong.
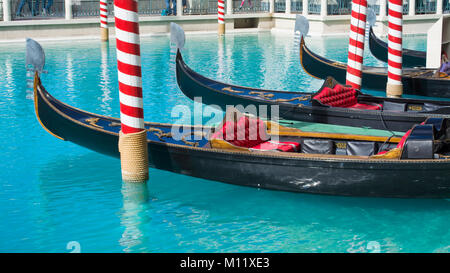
[176,51,450,131]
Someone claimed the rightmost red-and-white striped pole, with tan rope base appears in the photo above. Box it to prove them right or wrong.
[386,0,403,98]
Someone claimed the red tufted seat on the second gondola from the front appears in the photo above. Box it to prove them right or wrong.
[312,84,381,110]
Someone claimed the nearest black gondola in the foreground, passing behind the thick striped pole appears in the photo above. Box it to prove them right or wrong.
[34,39,450,198]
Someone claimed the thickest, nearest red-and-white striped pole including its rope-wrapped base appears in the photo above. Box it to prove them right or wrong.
[114,0,148,182]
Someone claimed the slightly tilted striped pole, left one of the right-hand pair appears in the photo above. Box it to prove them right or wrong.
[346,0,367,89]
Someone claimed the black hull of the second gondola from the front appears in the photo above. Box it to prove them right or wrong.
[176,52,450,131]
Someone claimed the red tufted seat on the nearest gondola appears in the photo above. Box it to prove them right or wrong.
[210,115,300,152]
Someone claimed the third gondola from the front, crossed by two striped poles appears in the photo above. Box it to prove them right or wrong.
[300,36,450,98]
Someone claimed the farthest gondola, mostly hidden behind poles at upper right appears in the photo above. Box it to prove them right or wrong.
[369,27,427,67]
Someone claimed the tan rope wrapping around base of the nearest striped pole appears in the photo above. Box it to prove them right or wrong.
[119,130,148,182]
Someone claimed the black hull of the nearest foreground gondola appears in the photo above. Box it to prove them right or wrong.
[35,75,450,198]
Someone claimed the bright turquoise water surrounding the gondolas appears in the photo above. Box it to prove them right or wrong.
[0,33,450,252]
